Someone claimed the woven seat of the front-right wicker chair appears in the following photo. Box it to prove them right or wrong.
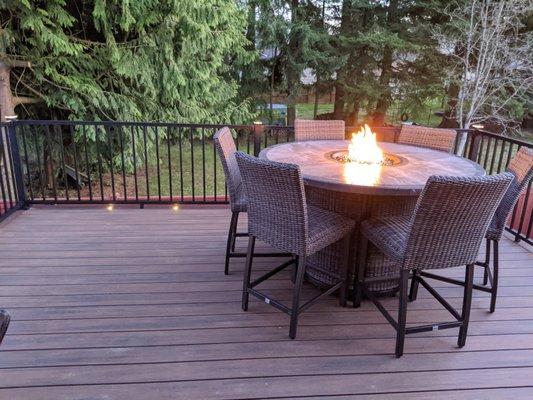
[361,215,411,262]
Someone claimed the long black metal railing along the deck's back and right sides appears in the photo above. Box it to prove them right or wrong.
[2,120,533,244]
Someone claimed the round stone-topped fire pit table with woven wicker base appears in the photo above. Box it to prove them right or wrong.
[259,140,485,294]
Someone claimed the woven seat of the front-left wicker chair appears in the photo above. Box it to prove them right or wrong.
[307,205,355,255]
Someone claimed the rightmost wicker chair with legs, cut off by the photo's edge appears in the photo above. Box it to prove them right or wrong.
[413,147,533,313]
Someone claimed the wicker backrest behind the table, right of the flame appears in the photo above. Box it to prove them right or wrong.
[398,124,457,152]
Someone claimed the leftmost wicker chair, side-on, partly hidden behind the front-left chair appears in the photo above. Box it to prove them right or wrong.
[213,127,287,275]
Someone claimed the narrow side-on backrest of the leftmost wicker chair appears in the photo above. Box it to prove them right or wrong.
[213,126,242,209]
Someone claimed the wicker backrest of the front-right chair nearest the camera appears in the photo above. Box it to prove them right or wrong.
[403,172,513,269]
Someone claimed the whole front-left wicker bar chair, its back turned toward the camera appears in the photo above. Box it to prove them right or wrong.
[236,152,355,339]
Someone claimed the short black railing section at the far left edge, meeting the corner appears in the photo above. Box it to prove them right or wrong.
[0,123,25,221]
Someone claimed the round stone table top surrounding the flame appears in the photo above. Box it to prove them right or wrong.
[259,140,485,196]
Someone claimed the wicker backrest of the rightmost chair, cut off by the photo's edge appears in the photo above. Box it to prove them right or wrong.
[491,147,533,239]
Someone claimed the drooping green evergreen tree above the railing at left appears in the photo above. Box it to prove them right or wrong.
[0,0,254,123]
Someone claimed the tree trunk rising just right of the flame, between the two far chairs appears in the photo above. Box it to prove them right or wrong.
[372,0,398,126]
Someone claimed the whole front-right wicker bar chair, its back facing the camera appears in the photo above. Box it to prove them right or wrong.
[354,173,513,357]
